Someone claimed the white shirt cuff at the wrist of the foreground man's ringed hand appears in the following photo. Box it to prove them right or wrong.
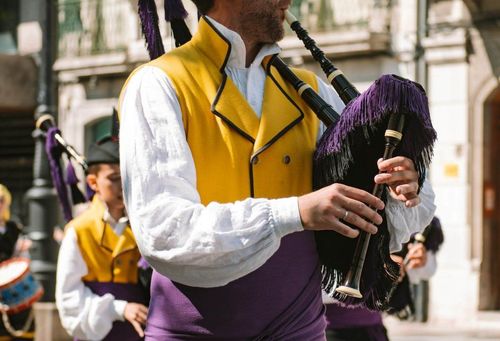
[270,197,304,238]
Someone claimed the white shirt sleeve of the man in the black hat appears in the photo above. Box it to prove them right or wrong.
[56,227,127,340]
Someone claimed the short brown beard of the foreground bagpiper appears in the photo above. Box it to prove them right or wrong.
[240,1,285,44]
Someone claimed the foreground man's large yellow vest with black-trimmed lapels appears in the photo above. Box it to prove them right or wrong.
[125,17,319,205]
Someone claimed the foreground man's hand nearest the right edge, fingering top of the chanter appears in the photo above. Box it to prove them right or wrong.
[375,156,420,207]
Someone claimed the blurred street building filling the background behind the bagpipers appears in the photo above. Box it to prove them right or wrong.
[0,0,500,334]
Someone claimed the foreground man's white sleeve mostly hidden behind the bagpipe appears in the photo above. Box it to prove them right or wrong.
[318,78,436,253]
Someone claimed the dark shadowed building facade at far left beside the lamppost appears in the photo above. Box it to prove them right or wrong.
[0,0,38,220]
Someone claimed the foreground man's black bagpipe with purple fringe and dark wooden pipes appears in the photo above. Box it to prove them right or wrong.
[138,0,436,310]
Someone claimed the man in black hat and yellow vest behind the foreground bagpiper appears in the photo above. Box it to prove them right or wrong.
[56,137,148,341]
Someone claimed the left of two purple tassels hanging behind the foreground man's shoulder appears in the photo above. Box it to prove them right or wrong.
[138,0,165,59]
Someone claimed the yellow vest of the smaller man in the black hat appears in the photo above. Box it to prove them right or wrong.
[68,196,141,284]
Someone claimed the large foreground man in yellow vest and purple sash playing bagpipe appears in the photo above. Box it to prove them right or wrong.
[120,0,434,340]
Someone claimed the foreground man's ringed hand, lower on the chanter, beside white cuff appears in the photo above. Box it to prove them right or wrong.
[299,184,384,238]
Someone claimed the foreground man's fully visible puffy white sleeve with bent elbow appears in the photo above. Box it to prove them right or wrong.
[120,67,303,287]
